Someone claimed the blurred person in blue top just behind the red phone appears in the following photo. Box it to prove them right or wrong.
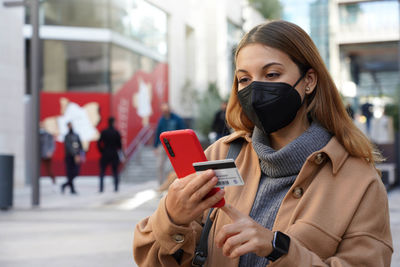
[154,103,186,186]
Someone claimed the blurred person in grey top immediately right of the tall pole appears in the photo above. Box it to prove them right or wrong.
[39,122,56,184]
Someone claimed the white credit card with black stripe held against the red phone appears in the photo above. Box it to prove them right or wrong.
[193,159,244,187]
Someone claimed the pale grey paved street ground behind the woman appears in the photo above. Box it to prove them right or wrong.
[0,177,400,267]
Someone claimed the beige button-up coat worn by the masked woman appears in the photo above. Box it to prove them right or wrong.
[133,132,393,267]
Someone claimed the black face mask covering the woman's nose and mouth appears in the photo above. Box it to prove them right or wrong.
[238,73,305,134]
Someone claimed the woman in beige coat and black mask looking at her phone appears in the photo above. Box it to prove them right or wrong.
[134,21,393,267]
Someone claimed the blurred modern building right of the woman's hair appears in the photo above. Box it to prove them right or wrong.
[281,0,400,186]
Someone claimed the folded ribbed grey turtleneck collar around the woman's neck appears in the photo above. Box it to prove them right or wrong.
[252,122,332,178]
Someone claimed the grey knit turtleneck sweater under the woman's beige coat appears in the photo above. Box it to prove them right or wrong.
[239,122,332,267]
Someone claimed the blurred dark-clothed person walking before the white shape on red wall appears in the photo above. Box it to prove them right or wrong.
[61,122,84,194]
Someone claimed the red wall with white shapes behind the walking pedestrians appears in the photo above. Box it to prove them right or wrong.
[40,63,168,176]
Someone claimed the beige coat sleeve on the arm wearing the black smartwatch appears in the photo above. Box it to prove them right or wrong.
[269,179,393,267]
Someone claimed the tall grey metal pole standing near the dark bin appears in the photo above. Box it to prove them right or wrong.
[30,0,40,206]
